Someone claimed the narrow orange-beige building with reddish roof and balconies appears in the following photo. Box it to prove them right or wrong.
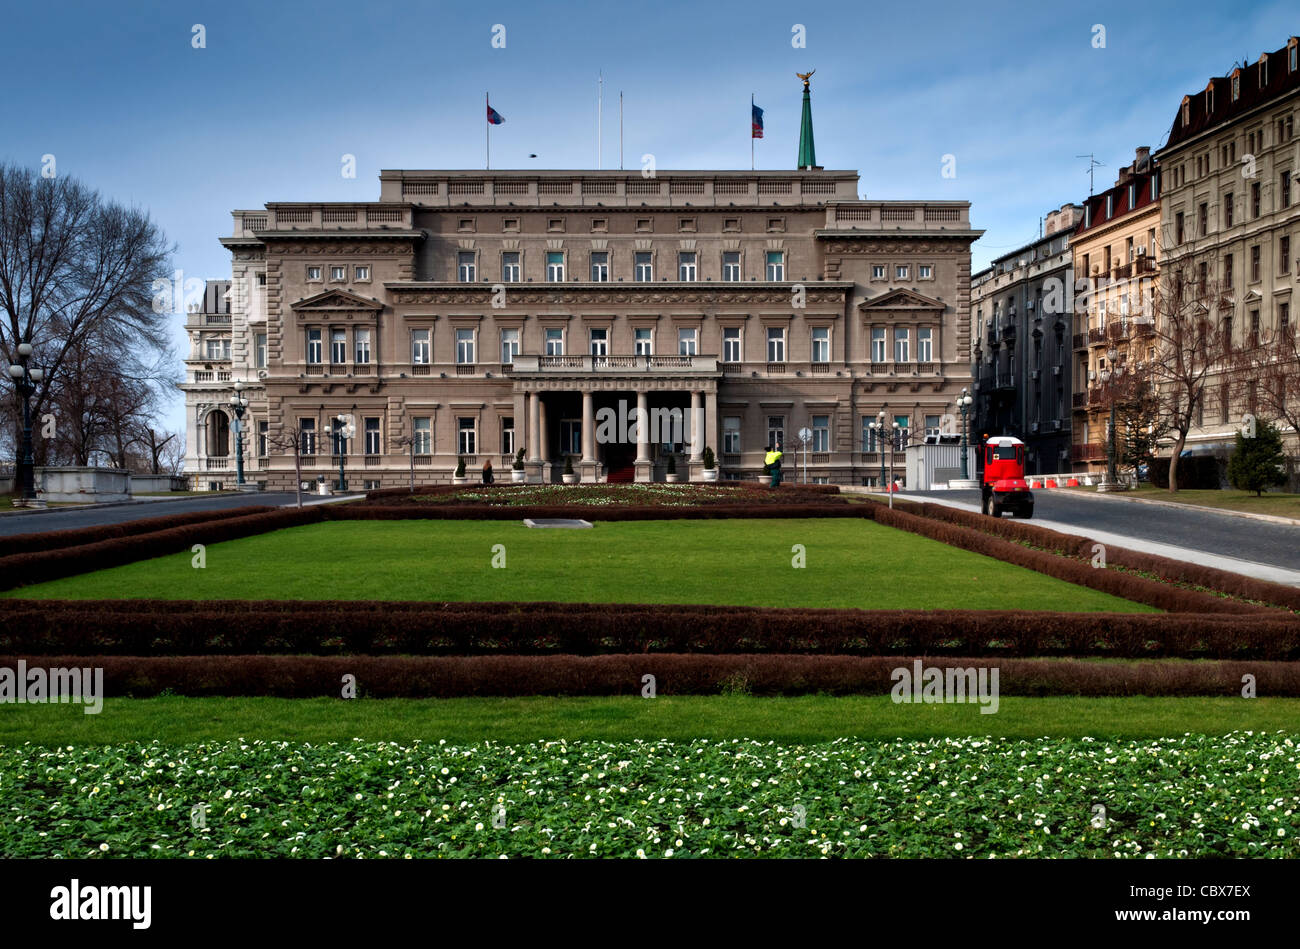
[1070,147,1161,473]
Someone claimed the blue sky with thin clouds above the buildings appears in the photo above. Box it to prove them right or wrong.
[0,0,1300,429]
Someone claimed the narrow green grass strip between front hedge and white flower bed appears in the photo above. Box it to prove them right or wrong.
[0,696,1300,745]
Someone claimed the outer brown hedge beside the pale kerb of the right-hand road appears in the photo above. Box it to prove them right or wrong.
[905,502,1300,610]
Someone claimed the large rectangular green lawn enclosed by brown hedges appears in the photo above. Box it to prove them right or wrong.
[7,519,1152,612]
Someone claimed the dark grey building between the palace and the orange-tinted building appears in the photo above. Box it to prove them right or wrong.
[970,204,1083,475]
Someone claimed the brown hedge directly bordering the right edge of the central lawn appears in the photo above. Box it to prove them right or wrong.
[861,504,1277,614]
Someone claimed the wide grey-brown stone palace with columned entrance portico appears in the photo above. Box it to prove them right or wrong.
[182,168,982,489]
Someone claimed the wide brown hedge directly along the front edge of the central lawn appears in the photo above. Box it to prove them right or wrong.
[0,599,1300,660]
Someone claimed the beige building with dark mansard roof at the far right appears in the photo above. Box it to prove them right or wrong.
[1156,36,1300,455]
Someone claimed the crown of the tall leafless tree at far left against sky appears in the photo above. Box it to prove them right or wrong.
[0,164,173,465]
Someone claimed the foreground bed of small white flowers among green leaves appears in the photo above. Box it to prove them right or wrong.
[0,732,1300,859]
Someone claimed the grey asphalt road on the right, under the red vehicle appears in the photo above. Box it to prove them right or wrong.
[911,489,1300,571]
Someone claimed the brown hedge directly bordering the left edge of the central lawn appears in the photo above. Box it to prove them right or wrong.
[0,507,324,590]
